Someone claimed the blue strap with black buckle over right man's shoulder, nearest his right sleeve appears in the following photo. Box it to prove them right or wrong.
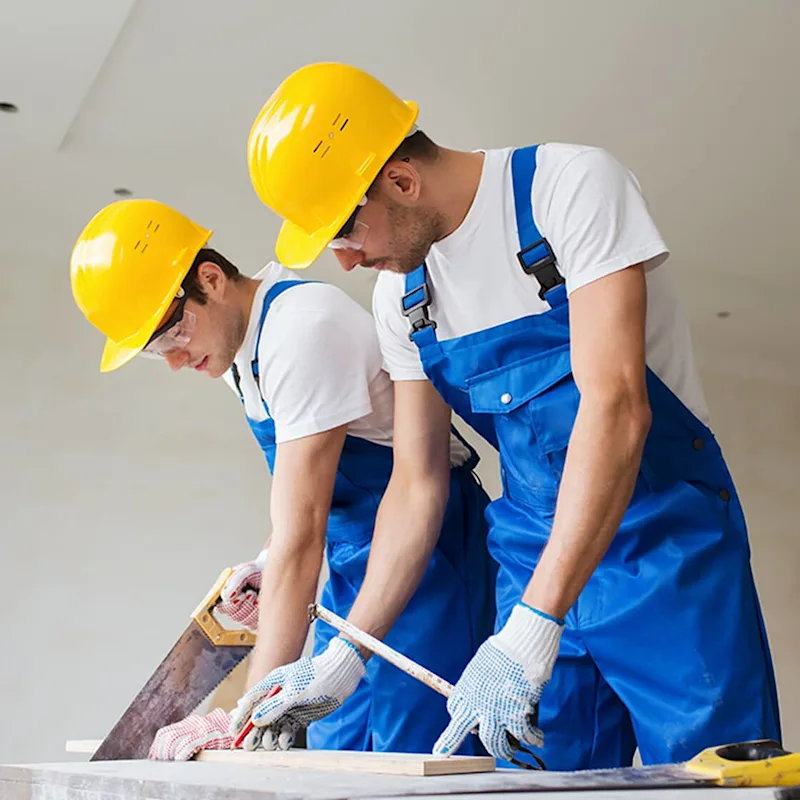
[511,145,566,305]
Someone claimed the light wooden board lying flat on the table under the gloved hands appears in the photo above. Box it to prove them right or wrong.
[67,739,495,777]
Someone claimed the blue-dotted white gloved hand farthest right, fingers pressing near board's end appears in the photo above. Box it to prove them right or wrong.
[433,603,564,760]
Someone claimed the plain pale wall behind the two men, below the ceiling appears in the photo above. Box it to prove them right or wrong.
[0,244,800,763]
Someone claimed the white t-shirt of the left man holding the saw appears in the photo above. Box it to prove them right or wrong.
[224,262,468,464]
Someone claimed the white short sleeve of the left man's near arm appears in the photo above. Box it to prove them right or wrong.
[259,304,380,444]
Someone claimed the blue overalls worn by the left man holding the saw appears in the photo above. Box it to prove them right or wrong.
[228,281,497,754]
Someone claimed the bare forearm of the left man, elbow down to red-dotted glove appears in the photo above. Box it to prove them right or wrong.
[247,543,323,688]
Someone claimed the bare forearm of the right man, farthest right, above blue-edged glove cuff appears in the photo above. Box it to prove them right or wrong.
[522,398,650,617]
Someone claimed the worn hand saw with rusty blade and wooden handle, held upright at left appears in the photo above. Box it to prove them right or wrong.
[91,568,256,761]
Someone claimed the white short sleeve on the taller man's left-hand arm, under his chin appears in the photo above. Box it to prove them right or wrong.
[372,272,427,381]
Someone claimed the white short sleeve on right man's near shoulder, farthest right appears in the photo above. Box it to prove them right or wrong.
[533,148,668,294]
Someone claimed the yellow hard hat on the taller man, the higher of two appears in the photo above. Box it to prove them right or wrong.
[247,63,418,269]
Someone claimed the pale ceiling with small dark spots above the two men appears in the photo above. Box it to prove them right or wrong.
[0,0,800,385]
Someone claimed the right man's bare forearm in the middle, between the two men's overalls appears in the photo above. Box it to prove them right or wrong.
[348,475,449,657]
